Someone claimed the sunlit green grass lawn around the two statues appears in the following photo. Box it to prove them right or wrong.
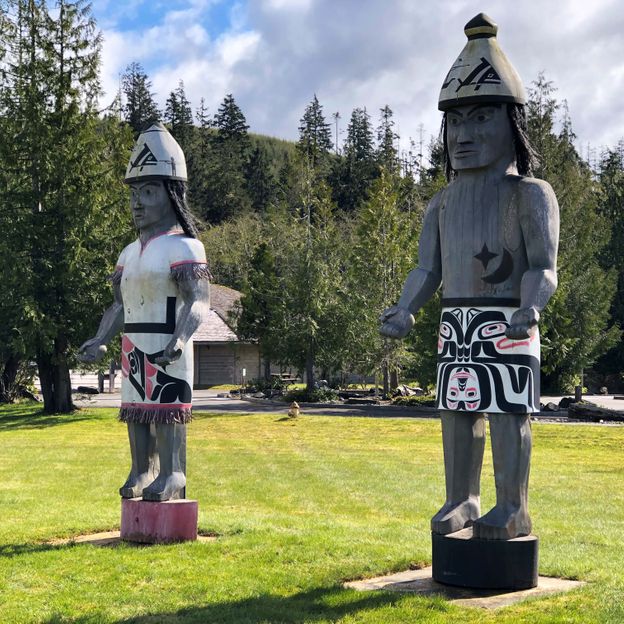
[0,405,624,624]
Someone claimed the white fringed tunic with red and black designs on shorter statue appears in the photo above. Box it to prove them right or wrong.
[116,231,206,423]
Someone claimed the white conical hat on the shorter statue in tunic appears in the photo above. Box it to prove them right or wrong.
[124,122,187,184]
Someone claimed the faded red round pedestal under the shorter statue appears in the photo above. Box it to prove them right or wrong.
[121,498,198,544]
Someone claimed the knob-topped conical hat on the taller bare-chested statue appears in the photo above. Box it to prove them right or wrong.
[438,13,527,111]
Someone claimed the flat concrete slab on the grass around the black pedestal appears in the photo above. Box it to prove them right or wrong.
[344,567,585,609]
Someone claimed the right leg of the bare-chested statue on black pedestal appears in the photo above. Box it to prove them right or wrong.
[474,414,531,540]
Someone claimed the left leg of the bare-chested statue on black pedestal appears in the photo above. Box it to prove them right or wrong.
[431,411,485,535]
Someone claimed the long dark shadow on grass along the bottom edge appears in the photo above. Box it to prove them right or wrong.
[46,587,445,624]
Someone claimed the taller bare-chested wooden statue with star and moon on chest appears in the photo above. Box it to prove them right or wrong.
[381,14,559,540]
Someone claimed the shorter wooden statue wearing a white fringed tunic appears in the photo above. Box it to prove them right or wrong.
[80,123,209,501]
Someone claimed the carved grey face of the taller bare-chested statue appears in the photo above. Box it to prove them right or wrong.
[446,104,515,171]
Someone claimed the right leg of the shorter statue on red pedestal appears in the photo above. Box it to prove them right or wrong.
[143,423,186,501]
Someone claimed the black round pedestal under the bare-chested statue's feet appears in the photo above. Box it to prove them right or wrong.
[431,528,539,590]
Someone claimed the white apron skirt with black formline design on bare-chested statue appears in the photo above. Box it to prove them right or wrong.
[437,308,540,413]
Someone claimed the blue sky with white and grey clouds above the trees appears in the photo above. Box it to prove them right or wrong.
[93,0,624,160]
